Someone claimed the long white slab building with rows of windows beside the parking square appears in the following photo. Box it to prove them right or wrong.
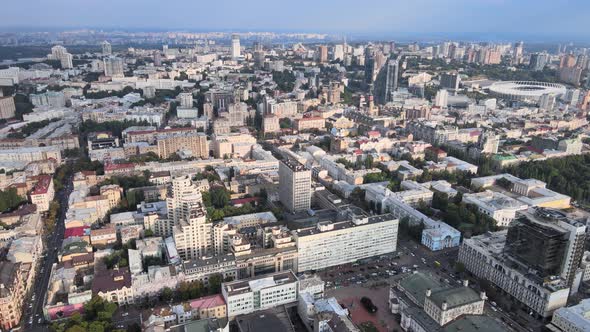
[293,210,399,272]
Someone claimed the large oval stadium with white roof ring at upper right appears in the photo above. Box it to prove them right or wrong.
[489,81,566,103]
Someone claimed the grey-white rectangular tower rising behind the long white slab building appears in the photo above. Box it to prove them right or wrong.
[279,159,311,212]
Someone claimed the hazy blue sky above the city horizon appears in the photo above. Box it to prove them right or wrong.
[0,0,590,41]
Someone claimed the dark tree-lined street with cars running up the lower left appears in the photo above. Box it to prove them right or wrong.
[23,178,72,331]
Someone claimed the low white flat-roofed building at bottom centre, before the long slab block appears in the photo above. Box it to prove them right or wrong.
[221,271,299,319]
